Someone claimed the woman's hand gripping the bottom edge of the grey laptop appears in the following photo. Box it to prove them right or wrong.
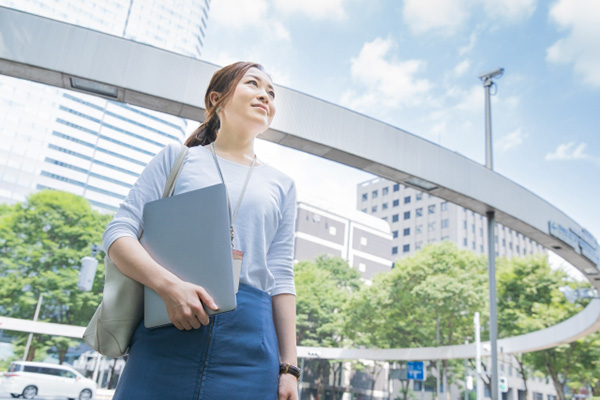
[158,280,219,330]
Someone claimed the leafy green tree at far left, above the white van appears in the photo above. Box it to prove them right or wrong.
[0,190,111,362]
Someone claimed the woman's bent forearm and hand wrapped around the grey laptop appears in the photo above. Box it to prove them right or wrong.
[108,236,217,330]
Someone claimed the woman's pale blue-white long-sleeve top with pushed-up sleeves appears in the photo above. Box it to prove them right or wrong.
[102,143,296,296]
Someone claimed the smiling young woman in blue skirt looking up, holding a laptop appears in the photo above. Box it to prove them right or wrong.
[103,62,298,400]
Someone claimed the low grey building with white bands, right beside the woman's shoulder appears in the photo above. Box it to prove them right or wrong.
[294,201,392,282]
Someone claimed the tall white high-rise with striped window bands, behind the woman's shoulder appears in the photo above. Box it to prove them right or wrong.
[0,0,210,211]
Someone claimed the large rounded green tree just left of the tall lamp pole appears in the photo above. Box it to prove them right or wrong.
[345,242,487,399]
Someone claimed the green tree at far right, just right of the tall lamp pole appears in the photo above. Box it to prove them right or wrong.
[498,256,599,400]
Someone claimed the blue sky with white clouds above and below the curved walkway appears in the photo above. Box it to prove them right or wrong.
[203,0,600,240]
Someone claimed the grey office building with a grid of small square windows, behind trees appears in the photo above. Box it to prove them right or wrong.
[356,178,544,260]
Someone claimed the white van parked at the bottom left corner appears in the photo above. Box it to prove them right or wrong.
[0,361,96,400]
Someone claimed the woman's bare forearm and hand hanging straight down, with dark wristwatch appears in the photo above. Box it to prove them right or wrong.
[272,293,298,400]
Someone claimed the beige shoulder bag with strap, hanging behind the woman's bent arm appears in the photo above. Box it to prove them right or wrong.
[83,145,188,358]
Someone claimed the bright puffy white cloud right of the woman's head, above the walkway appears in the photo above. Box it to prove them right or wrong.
[341,38,431,109]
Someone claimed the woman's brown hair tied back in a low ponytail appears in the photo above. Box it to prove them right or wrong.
[185,61,264,147]
